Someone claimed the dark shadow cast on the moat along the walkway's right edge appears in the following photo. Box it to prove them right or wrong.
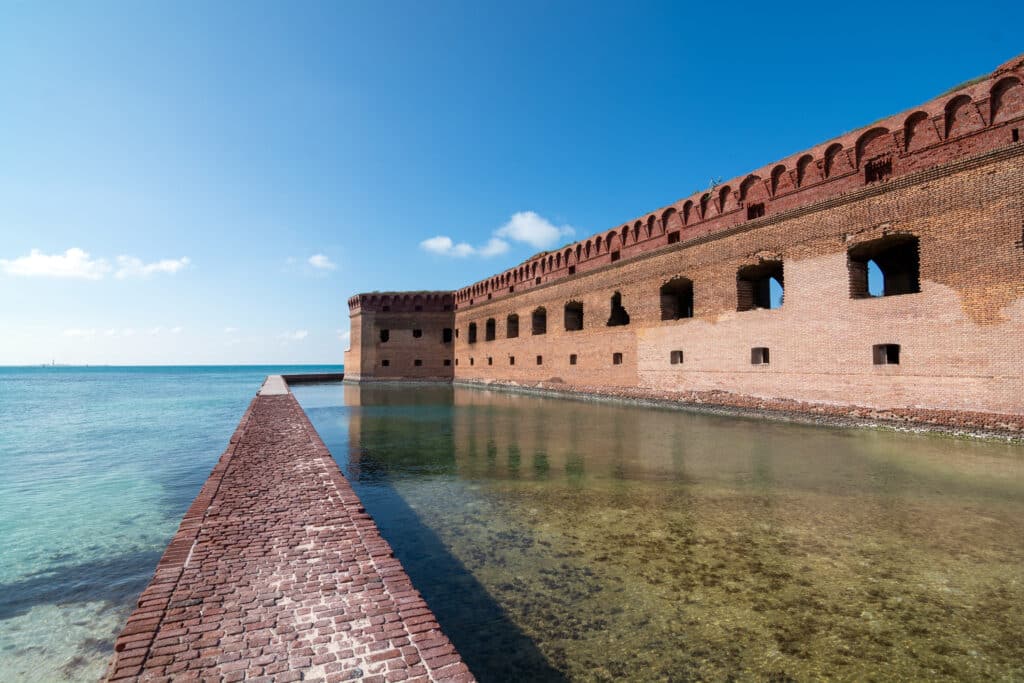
[306,399,567,682]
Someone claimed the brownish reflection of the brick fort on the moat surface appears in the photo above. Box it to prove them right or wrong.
[343,383,978,496]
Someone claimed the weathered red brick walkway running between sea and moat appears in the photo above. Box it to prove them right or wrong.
[108,392,474,682]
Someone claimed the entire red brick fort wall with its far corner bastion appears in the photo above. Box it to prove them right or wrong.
[345,55,1024,424]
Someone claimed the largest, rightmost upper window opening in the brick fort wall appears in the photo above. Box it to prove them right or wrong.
[847,234,921,299]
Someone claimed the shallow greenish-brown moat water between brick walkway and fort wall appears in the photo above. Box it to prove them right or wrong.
[295,384,1024,681]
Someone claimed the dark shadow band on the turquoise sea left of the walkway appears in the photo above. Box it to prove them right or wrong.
[0,550,161,620]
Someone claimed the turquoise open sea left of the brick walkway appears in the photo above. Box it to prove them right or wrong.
[0,367,340,682]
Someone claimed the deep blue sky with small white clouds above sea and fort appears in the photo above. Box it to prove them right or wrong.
[0,2,1024,365]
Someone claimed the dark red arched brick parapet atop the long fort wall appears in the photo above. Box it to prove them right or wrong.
[456,55,1024,309]
